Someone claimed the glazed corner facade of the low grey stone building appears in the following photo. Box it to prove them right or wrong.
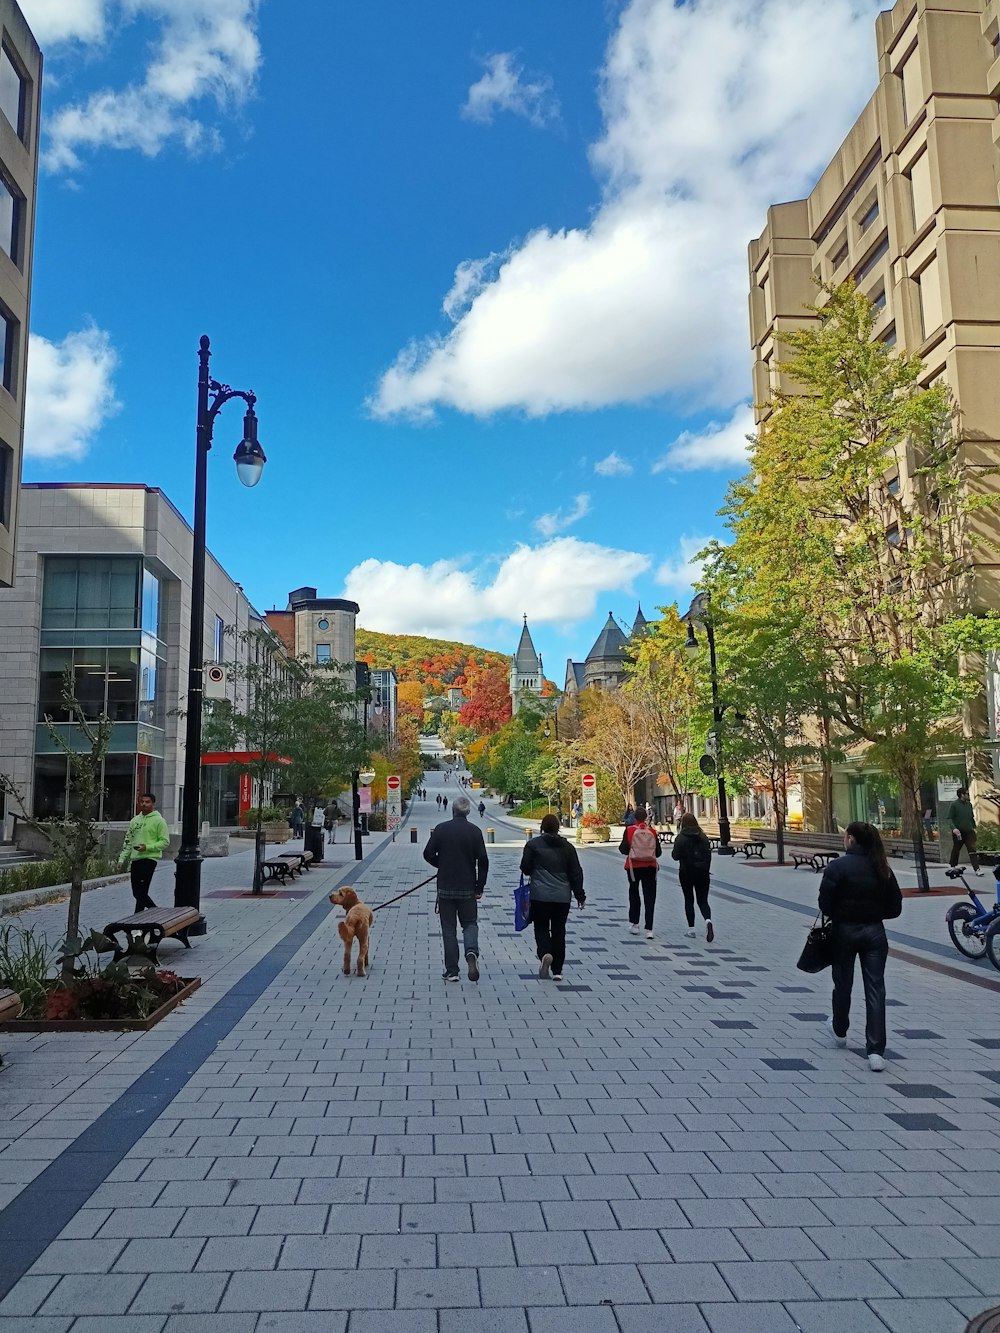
[32,556,167,820]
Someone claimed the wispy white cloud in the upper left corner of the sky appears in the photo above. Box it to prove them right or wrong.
[25,0,260,171]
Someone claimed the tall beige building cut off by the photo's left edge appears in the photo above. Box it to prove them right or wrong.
[0,0,41,588]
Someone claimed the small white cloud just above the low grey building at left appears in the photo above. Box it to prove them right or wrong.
[24,325,121,459]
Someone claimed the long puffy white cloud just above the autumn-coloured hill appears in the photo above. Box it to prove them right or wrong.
[344,537,651,640]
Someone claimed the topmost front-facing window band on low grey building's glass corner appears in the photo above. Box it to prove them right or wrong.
[41,556,141,629]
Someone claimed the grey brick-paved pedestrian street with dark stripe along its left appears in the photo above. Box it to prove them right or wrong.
[0,774,1000,1333]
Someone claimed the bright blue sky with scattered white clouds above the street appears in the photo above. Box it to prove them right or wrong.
[20,0,880,684]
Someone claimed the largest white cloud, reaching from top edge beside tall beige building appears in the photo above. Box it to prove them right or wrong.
[369,0,883,417]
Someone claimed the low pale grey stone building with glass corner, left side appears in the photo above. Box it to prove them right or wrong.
[0,483,278,832]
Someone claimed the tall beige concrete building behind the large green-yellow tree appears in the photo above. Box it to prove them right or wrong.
[749,0,1000,822]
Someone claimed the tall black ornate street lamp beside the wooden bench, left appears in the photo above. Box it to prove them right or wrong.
[173,335,267,934]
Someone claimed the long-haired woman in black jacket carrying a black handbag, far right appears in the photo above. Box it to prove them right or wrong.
[820,820,903,1073]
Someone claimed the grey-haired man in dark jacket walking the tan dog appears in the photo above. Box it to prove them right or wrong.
[424,796,489,981]
